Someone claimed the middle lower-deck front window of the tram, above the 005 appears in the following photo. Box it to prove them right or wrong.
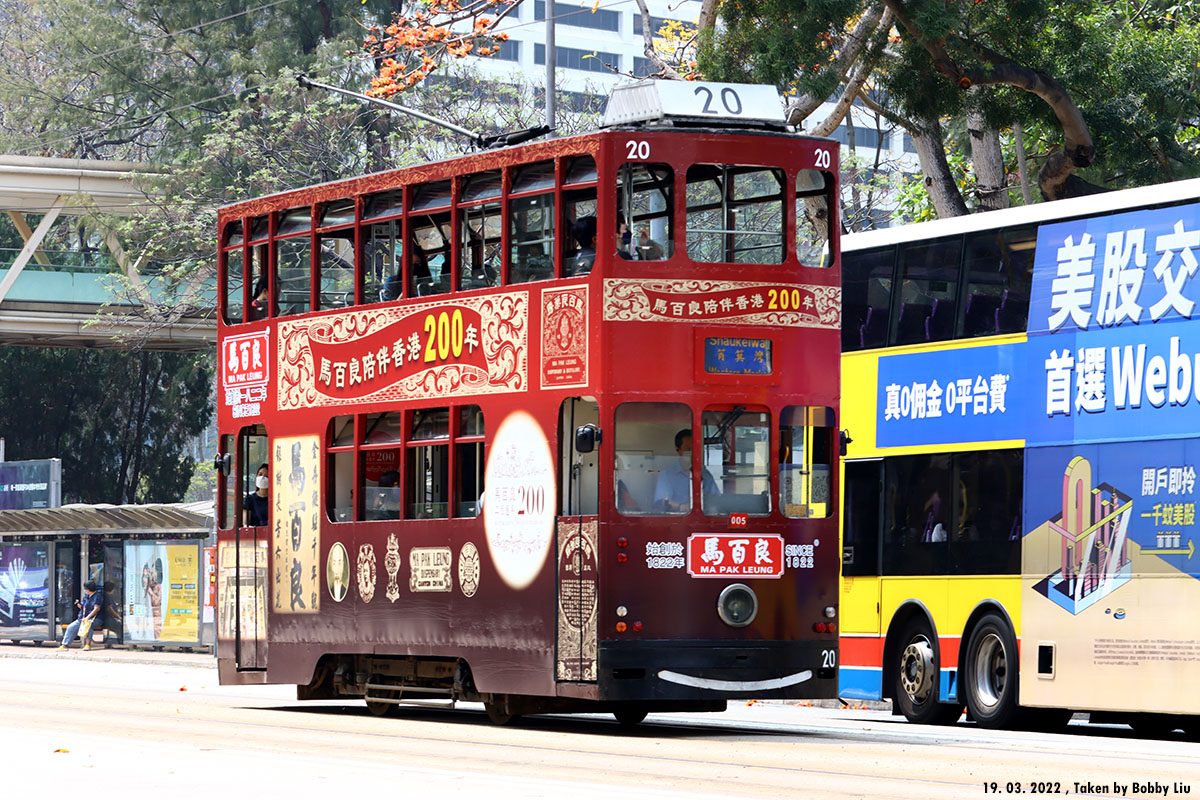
[700,407,772,517]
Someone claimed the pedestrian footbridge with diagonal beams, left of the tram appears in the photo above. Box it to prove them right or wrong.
[0,156,216,350]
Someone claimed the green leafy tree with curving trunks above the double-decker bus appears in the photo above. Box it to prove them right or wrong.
[700,0,1200,215]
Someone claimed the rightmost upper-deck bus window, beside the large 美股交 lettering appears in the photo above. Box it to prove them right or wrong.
[961,227,1038,338]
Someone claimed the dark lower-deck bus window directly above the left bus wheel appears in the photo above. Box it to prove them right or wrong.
[883,453,954,575]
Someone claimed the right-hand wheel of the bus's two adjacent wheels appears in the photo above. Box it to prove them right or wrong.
[964,614,1020,728]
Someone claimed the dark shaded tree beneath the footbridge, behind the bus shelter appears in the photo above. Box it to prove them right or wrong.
[0,347,212,503]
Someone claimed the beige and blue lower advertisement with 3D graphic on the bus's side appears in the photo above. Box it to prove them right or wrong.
[1020,439,1200,714]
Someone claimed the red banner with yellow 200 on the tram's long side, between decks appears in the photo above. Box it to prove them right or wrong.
[277,291,529,410]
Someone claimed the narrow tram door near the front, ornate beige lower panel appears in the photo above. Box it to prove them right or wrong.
[556,397,601,681]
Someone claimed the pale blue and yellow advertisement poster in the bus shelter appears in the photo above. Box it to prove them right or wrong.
[122,542,200,644]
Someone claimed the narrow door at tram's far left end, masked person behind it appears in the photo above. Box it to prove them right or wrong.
[234,425,274,669]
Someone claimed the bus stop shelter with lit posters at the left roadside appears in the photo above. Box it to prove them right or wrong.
[0,501,215,648]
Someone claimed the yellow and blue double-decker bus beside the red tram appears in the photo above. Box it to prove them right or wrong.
[840,180,1200,735]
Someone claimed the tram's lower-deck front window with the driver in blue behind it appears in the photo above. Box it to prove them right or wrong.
[613,403,692,516]
